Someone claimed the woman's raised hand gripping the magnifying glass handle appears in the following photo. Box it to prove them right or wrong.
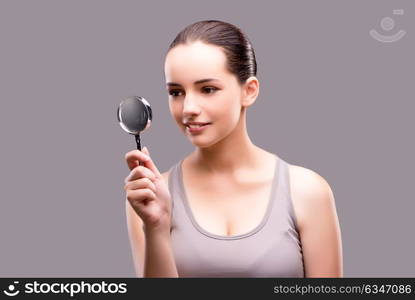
[124,147,172,231]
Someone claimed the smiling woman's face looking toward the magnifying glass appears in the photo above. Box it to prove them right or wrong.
[164,41,242,148]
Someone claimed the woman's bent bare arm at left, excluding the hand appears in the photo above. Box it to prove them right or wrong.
[126,172,178,277]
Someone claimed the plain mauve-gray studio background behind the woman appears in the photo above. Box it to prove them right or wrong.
[0,0,415,277]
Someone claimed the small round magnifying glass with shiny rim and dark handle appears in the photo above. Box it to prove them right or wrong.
[117,96,153,151]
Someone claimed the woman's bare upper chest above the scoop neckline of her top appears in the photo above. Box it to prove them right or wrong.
[183,176,273,236]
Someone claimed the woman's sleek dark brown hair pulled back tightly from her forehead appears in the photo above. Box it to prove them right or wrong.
[167,20,257,84]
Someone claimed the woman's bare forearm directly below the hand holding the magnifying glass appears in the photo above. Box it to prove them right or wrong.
[144,230,179,277]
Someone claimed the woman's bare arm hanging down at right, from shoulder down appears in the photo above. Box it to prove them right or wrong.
[290,166,343,277]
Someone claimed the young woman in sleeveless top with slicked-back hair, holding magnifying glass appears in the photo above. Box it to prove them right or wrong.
[124,20,343,277]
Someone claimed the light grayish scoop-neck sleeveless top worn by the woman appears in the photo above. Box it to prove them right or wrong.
[168,155,304,277]
